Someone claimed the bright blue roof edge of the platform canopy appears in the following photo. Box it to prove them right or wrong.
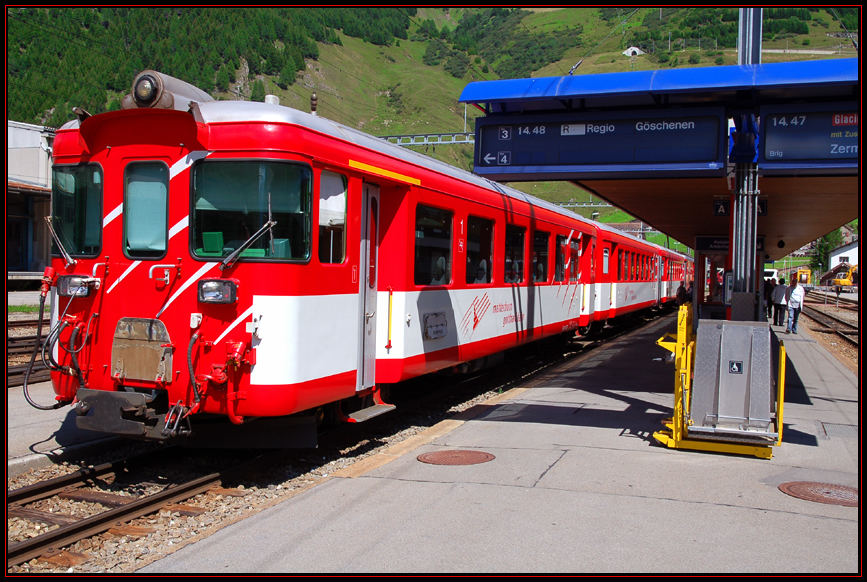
[460,58,859,113]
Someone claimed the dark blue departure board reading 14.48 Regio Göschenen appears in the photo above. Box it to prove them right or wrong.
[475,108,727,180]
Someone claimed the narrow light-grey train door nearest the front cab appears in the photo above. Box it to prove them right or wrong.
[356,183,379,391]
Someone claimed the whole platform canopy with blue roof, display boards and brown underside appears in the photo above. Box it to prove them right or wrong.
[460,59,861,260]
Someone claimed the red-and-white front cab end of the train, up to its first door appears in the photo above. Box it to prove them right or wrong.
[45,111,402,439]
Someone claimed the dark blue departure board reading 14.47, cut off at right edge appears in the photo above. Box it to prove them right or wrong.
[759,102,860,175]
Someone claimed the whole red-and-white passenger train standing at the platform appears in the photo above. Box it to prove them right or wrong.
[32,71,691,448]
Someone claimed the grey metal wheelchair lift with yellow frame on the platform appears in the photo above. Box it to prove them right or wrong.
[653,305,786,459]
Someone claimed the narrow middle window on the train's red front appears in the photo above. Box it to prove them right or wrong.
[123,162,169,259]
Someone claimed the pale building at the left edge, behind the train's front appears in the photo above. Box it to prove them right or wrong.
[6,120,54,279]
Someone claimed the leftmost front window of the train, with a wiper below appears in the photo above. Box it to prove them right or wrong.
[51,164,103,256]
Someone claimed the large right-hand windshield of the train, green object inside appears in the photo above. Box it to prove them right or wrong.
[190,161,312,260]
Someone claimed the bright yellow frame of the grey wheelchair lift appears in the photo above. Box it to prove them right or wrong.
[653,305,786,459]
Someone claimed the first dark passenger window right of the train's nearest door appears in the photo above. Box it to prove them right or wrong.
[414,204,452,285]
